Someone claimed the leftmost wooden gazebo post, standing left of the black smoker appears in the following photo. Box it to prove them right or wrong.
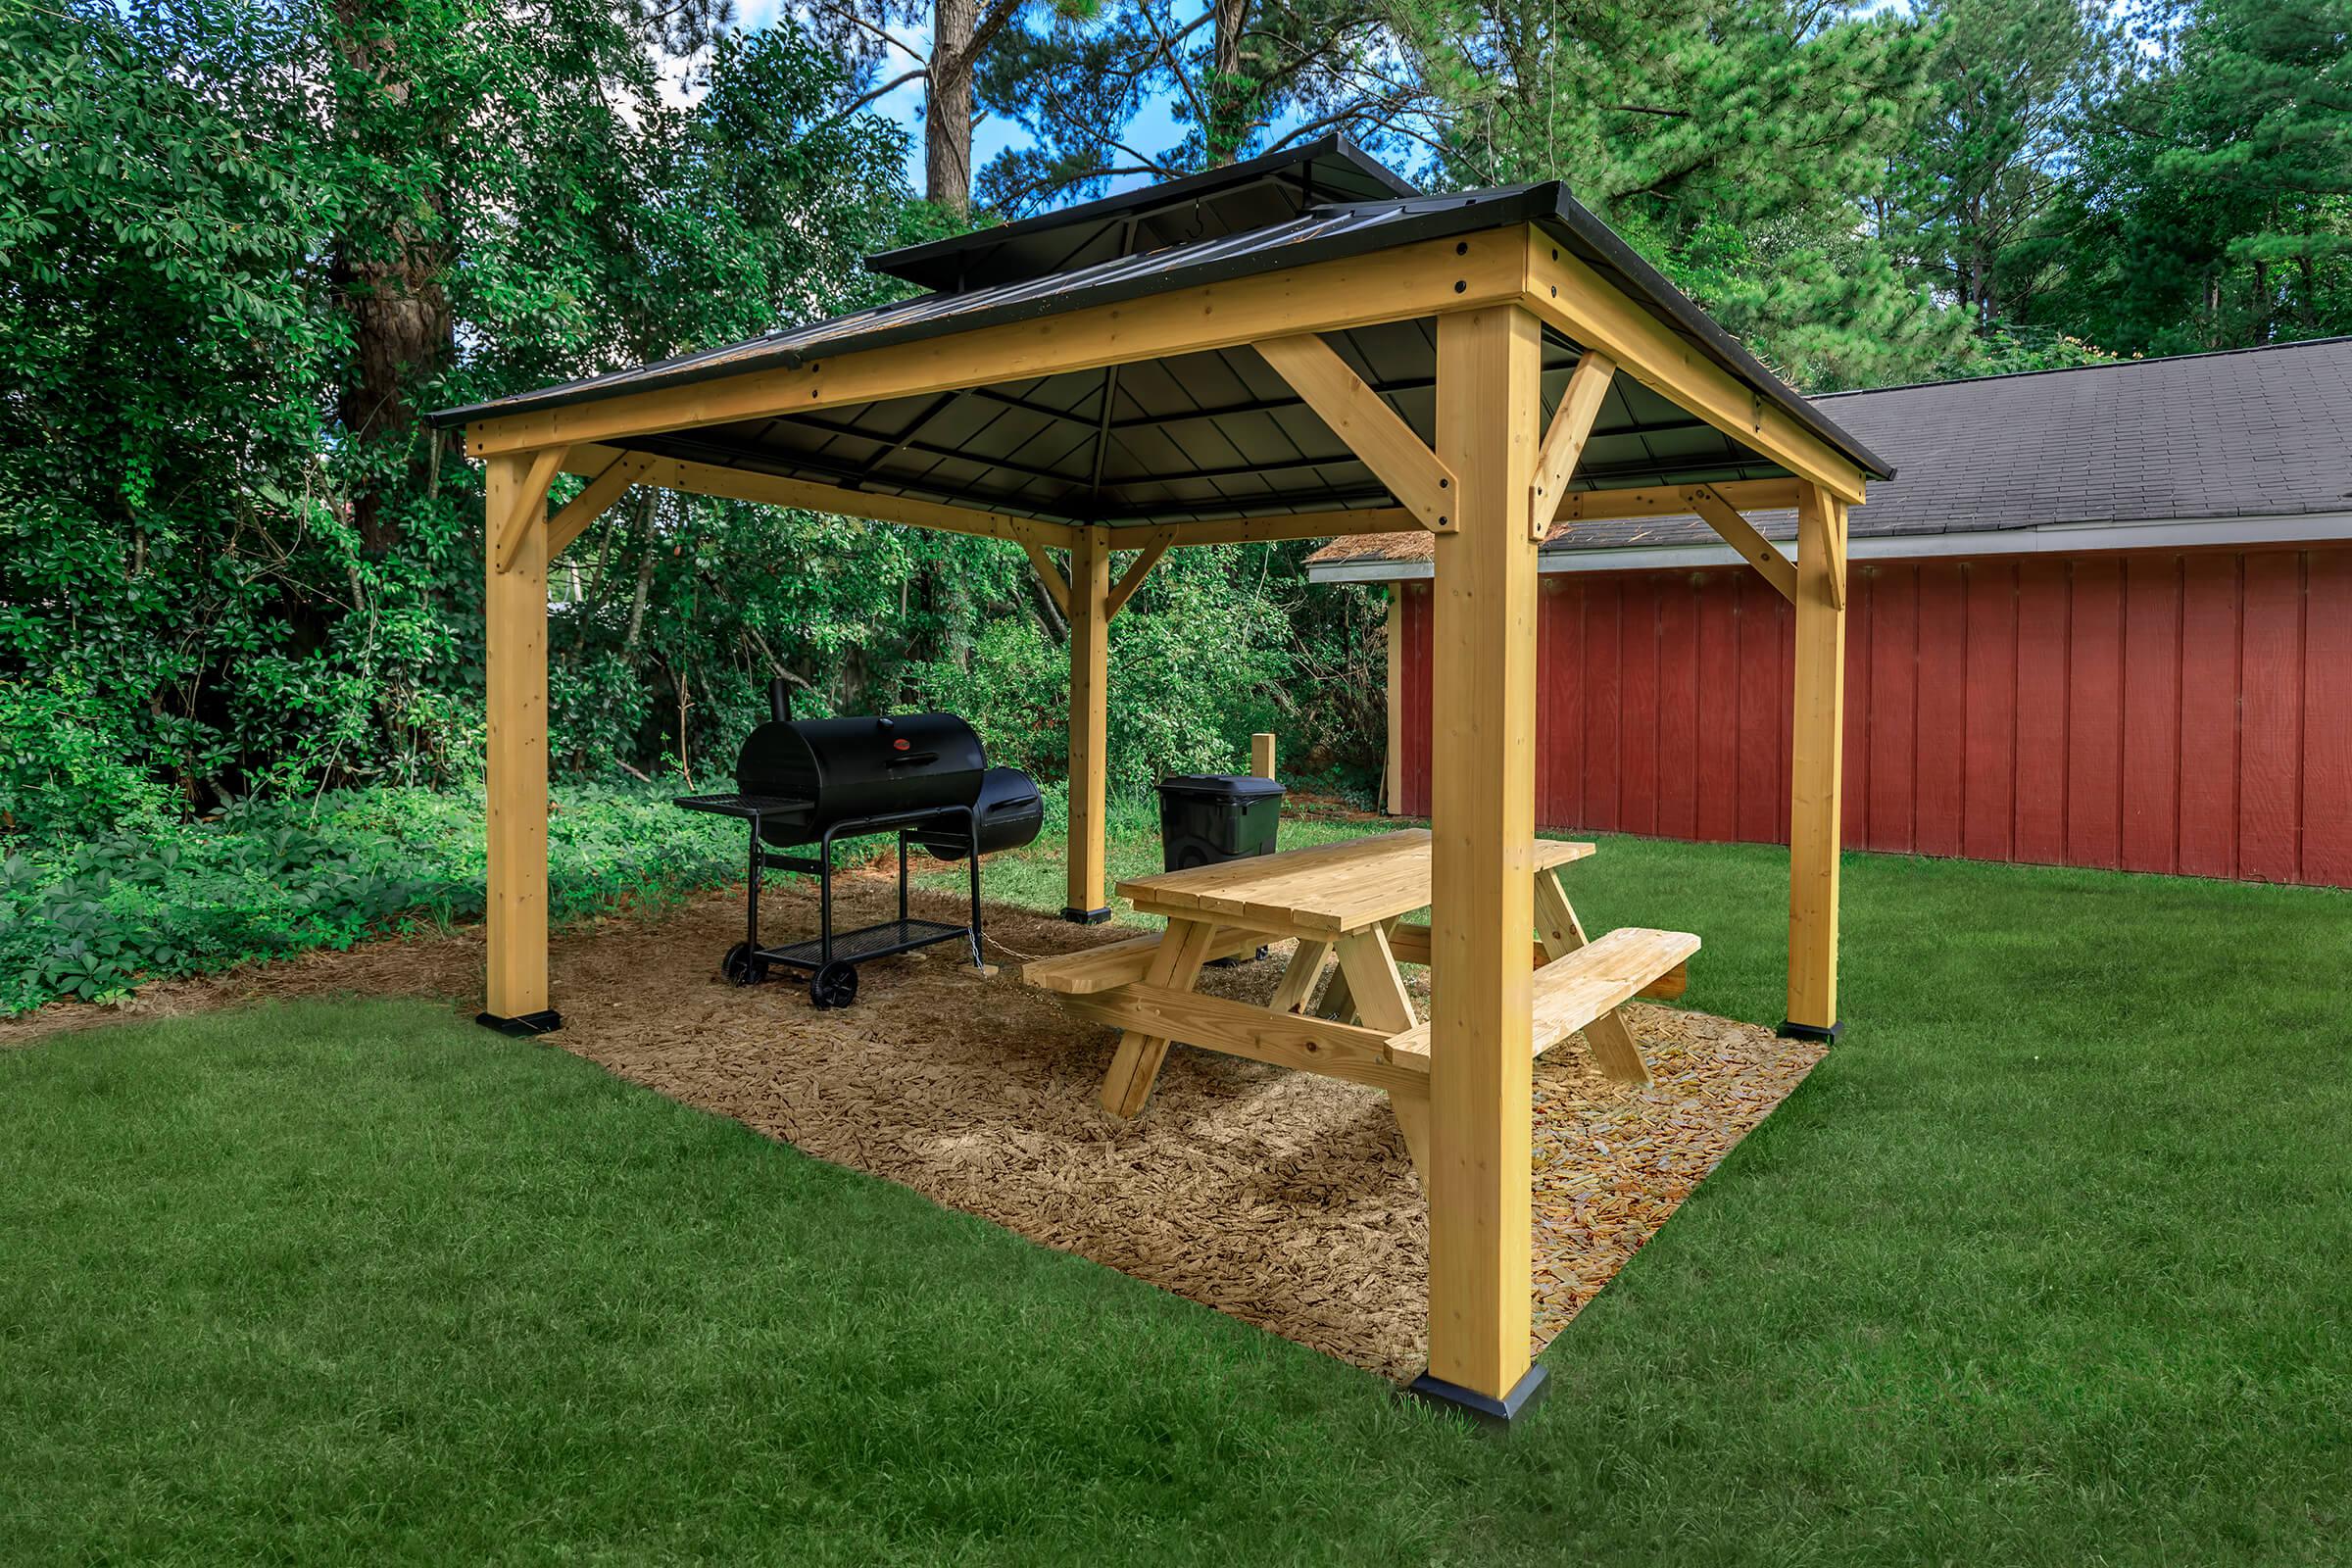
[482,452,563,1034]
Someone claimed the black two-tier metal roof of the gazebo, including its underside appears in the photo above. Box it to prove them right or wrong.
[433,136,1893,526]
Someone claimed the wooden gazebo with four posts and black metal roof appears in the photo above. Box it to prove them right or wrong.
[437,139,1891,1415]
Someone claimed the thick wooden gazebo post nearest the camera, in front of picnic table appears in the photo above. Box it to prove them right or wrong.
[1413,306,1543,1420]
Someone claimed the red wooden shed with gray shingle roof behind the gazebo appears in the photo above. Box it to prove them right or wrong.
[1307,338,2352,886]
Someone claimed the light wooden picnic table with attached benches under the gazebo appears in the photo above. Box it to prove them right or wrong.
[1021,827,1698,1175]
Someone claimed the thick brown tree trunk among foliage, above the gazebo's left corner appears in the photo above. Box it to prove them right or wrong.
[331,0,457,555]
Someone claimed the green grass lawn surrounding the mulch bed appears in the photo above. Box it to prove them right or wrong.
[0,825,2352,1566]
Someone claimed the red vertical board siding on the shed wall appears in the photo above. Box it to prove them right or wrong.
[1399,548,2352,886]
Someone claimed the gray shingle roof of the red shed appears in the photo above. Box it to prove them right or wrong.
[1312,338,2352,562]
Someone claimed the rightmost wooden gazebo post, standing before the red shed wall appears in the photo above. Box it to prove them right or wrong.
[1781,484,1846,1039]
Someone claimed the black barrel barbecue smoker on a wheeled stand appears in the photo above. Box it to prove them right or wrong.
[675,679,1045,1006]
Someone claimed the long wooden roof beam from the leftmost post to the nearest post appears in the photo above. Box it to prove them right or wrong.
[466,228,1527,456]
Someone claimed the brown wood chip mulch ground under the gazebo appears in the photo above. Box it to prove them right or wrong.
[0,877,1821,1378]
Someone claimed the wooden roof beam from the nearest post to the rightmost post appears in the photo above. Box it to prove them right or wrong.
[1527,228,1863,501]
